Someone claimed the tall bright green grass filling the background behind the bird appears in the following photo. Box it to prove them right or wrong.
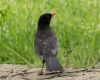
[0,0,100,68]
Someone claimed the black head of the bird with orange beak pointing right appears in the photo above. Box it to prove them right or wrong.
[38,12,56,29]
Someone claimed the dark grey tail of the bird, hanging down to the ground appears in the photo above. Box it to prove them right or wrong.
[45,56,63,72]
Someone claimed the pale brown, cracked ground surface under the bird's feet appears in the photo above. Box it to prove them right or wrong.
[0,64,100,80]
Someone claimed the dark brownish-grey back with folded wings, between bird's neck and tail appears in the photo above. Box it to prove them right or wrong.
[35,29,58,57]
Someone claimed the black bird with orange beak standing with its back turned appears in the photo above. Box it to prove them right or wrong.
[34,12,63,74]
